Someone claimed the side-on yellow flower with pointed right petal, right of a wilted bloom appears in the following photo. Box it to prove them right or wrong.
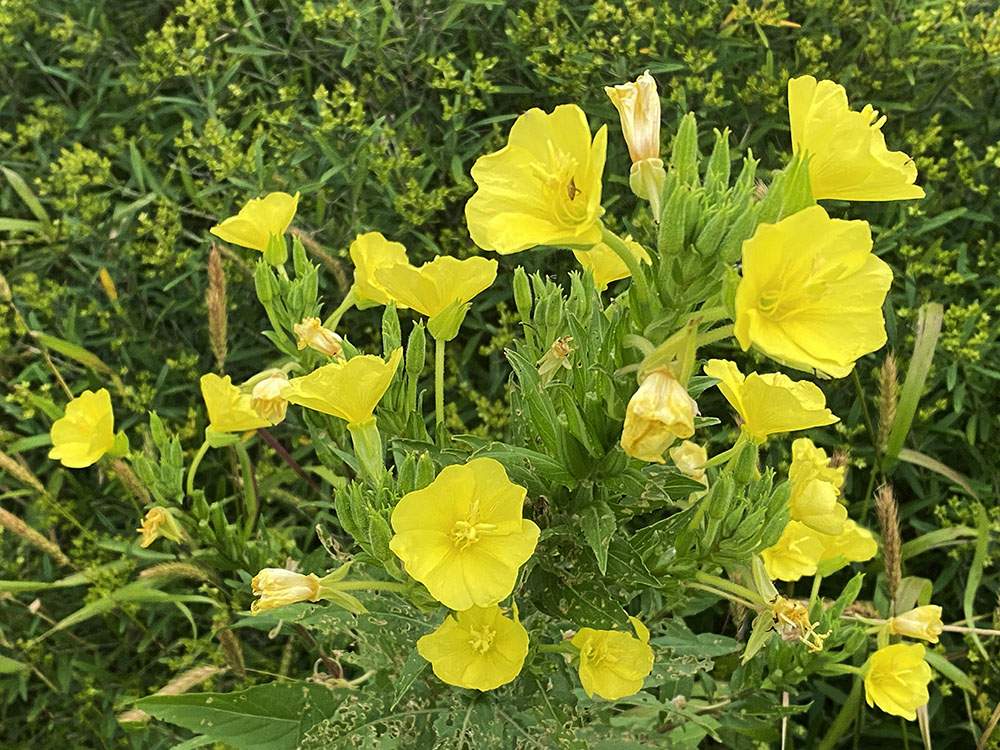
[282,349,403,425]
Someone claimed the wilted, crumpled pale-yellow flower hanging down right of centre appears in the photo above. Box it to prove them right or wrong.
[621,370,698,464]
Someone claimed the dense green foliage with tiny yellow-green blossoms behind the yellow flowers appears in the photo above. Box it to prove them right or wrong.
[0,0,1000,748]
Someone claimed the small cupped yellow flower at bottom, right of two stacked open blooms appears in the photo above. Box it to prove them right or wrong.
[570,617,653,701]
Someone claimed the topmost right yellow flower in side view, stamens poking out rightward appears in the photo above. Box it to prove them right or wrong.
[788,76,924,201]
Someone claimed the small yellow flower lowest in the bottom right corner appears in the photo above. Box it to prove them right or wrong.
[865,643,931,721]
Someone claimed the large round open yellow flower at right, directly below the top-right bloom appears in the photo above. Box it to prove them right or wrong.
[734,206,892,378]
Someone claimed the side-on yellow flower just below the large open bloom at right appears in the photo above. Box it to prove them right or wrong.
[705,359,838,442]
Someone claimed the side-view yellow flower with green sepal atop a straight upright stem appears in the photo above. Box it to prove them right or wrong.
[375,255,497,341]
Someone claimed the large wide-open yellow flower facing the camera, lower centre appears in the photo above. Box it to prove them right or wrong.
[389,458,539,610]
